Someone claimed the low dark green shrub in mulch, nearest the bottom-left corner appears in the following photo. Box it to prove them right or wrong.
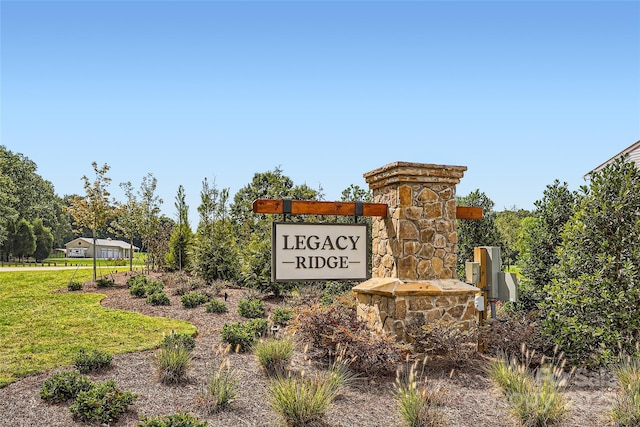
[69,380,138,424]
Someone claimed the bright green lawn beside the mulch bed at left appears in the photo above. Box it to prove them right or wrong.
[0,270,196,387]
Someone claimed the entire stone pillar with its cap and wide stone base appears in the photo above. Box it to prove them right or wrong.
[354,162,478,342]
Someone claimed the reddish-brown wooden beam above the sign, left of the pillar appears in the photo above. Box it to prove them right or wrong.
[253,199,387,216]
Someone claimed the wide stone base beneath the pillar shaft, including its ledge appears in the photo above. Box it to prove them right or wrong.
[353,278,480,343]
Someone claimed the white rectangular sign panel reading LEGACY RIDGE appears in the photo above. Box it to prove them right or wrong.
[271,222,369,282]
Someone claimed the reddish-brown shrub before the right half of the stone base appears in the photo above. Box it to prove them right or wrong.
[410,319,478,367]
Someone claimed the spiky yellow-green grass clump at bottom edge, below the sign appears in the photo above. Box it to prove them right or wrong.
[267,374,336,427]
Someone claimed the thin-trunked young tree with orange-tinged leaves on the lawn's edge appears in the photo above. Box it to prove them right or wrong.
[68,162,118,282]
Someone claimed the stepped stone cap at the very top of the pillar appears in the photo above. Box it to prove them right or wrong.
[363,162,467,190]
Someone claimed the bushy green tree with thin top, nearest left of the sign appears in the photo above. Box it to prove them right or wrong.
[191,178,240,283]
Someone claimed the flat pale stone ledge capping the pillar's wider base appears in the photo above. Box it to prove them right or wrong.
[353,277,480,297]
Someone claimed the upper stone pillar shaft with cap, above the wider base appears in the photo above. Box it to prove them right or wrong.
[364,162,467,280]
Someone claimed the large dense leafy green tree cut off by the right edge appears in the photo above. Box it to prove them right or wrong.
[542,158,640,366]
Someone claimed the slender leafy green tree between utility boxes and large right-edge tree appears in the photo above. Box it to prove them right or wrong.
[518,180,578,311]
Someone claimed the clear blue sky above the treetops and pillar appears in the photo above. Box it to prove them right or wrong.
[0,0,640,223]
